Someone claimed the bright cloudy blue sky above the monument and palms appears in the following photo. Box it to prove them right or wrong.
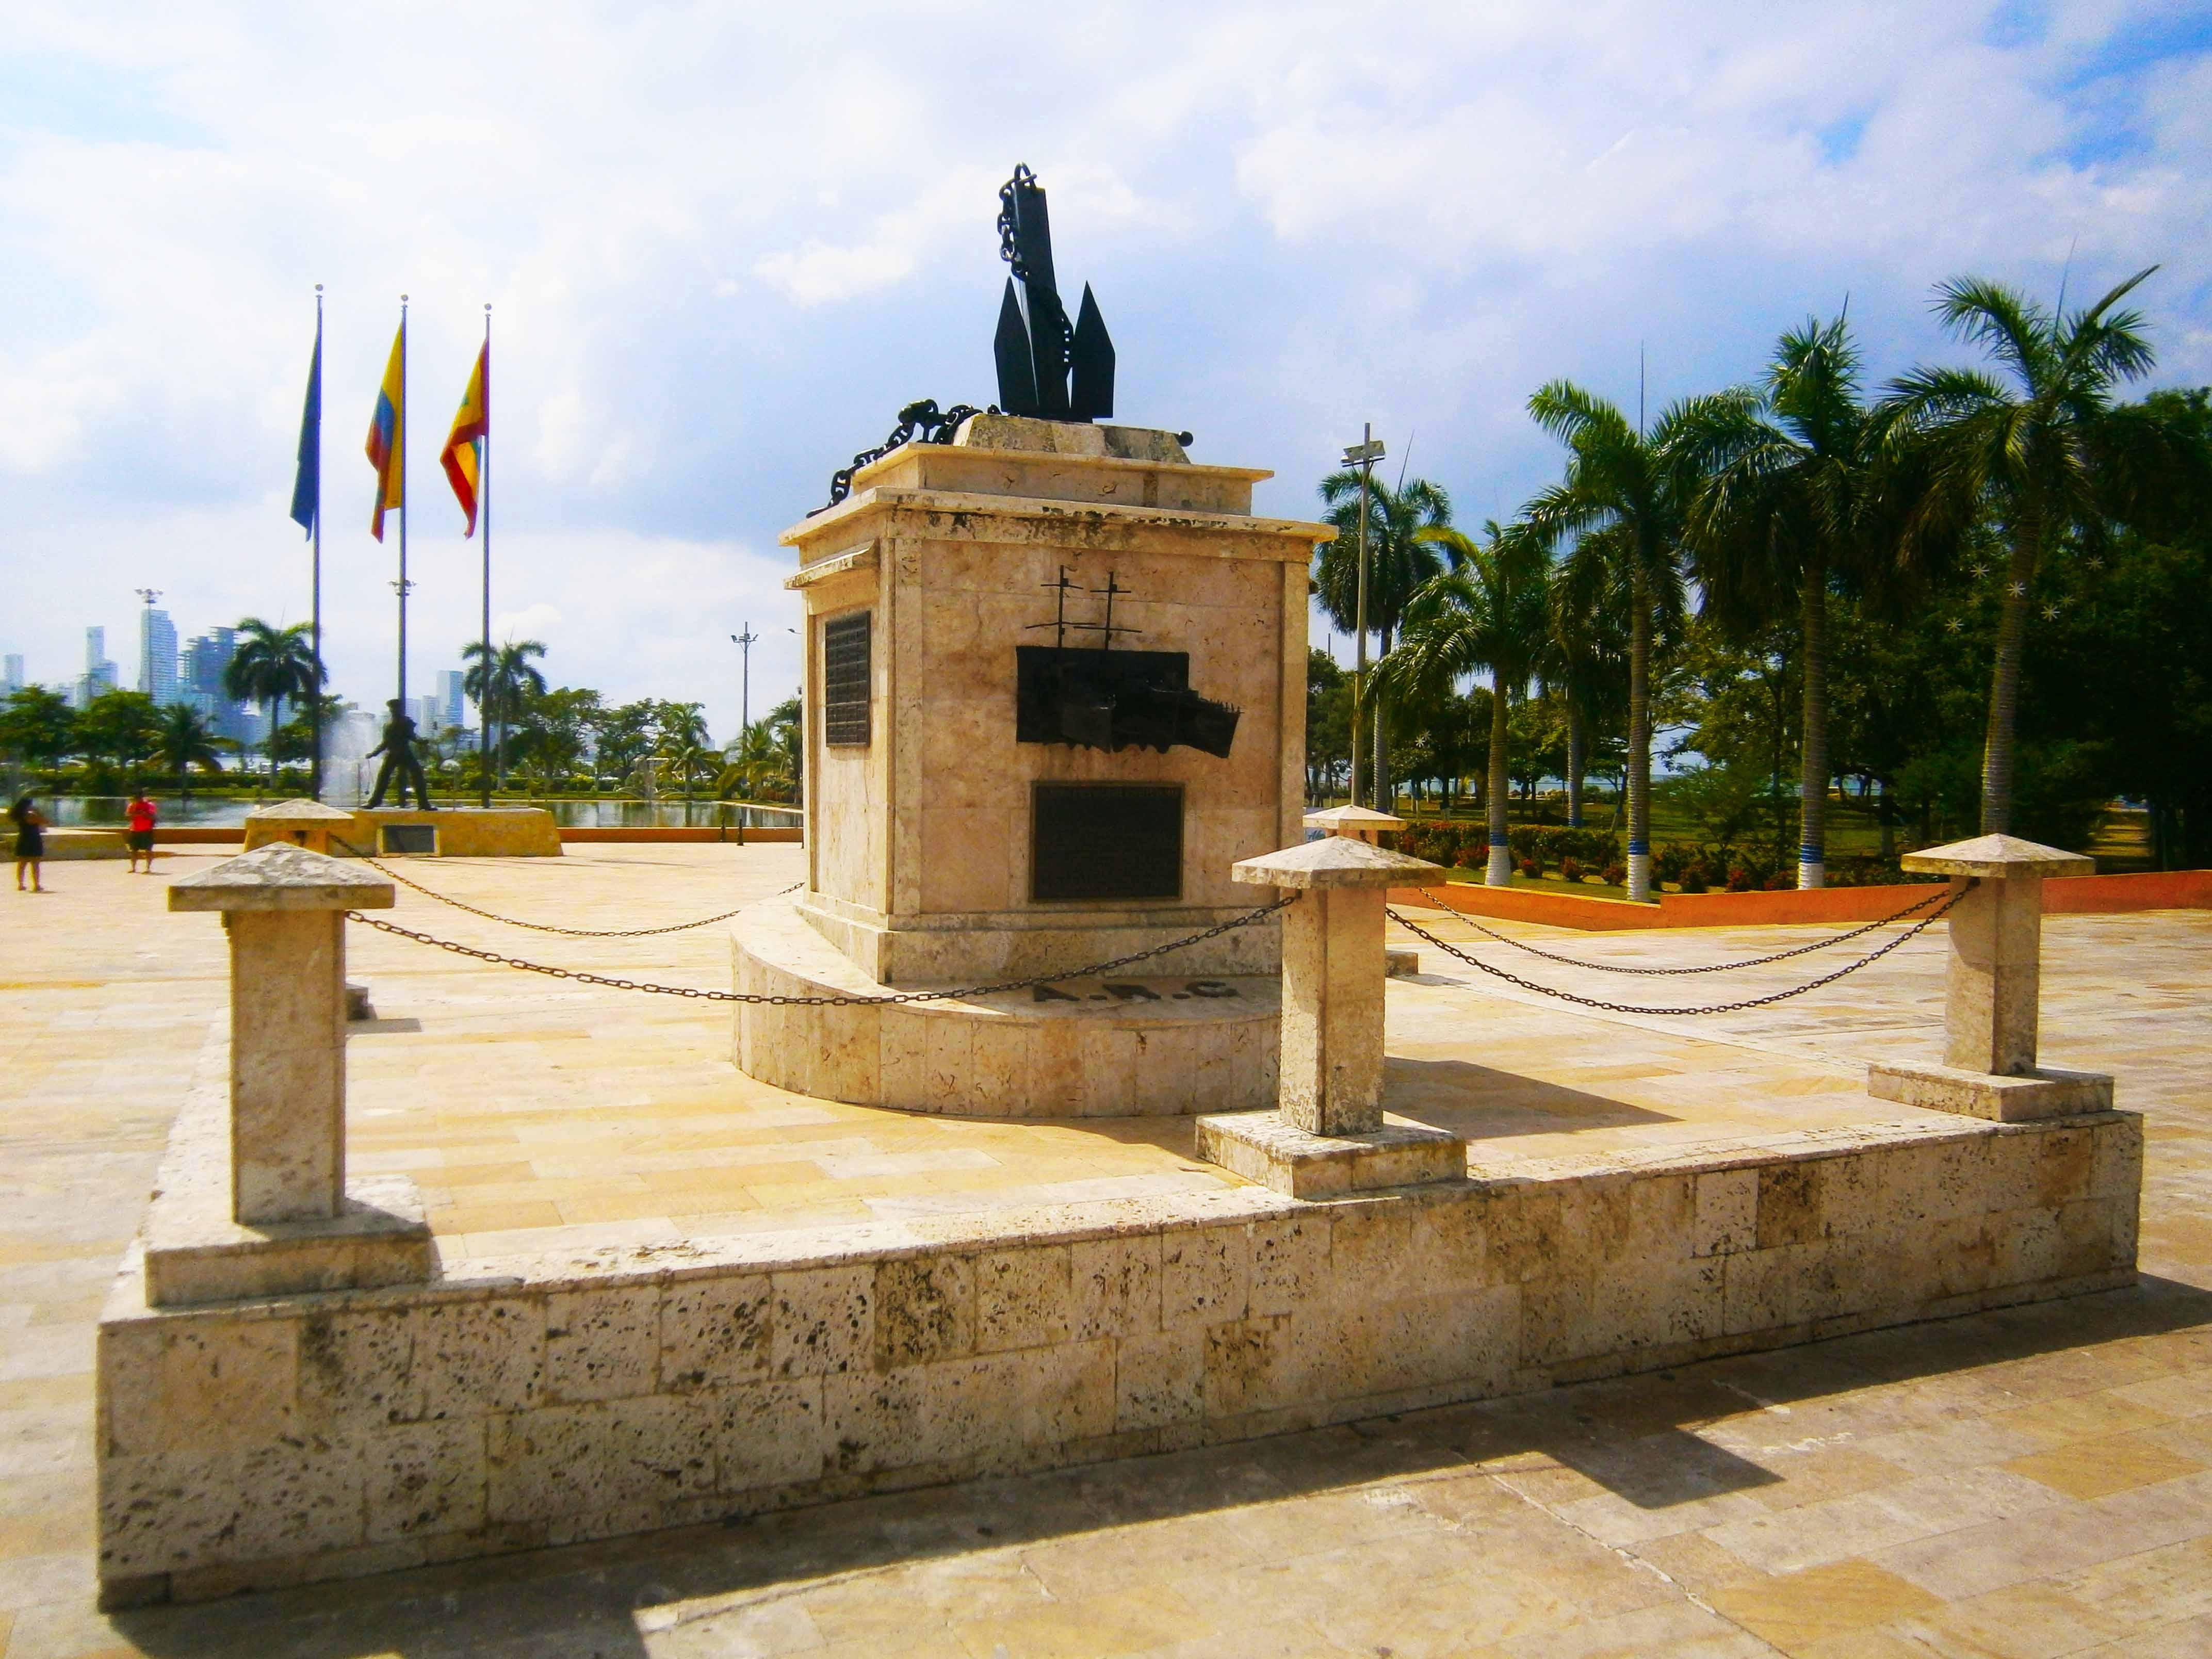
[0,0,2212,739]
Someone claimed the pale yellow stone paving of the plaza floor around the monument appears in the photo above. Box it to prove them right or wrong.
[0,845,2212,1659]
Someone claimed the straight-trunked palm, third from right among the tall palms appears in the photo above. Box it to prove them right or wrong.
[1526,381,1699,900]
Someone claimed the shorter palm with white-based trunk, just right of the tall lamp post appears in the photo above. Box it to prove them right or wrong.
[1378,520,1551,887]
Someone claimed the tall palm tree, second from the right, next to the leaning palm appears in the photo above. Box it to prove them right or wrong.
[1685,316,1911,887]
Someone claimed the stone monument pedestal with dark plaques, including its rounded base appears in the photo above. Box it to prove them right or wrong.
[732,414,1331,1117]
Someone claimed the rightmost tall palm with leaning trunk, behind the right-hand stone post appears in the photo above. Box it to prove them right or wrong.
[1891,276,2212,834]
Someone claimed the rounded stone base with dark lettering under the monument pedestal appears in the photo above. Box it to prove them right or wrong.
[730,898,1281,1117]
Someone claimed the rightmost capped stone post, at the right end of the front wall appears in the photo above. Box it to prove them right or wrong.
[1867,836,2112,1124]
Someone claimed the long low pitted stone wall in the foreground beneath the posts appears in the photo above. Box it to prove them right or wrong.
[97,1113,2141,1604]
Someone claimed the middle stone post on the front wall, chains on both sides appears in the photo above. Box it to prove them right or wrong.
[1199,834,1467,1199]
